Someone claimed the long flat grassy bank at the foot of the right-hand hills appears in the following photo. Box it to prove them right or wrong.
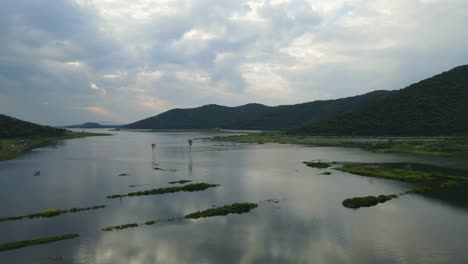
[211,132,468,156]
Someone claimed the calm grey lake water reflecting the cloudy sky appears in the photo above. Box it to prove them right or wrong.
[0,131,468,264]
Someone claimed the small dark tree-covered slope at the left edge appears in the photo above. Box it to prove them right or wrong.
[0,114,65,138]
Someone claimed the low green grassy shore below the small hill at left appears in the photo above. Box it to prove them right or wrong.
[0,131,111,160]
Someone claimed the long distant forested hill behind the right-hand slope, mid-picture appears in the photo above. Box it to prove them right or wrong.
[124,91,392,130]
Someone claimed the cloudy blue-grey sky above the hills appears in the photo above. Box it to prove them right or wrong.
[0,0,468,125]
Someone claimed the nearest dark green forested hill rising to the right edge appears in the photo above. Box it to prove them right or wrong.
[288,65,468,136]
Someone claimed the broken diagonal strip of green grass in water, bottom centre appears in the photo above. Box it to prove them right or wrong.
[101,200,260,231]
